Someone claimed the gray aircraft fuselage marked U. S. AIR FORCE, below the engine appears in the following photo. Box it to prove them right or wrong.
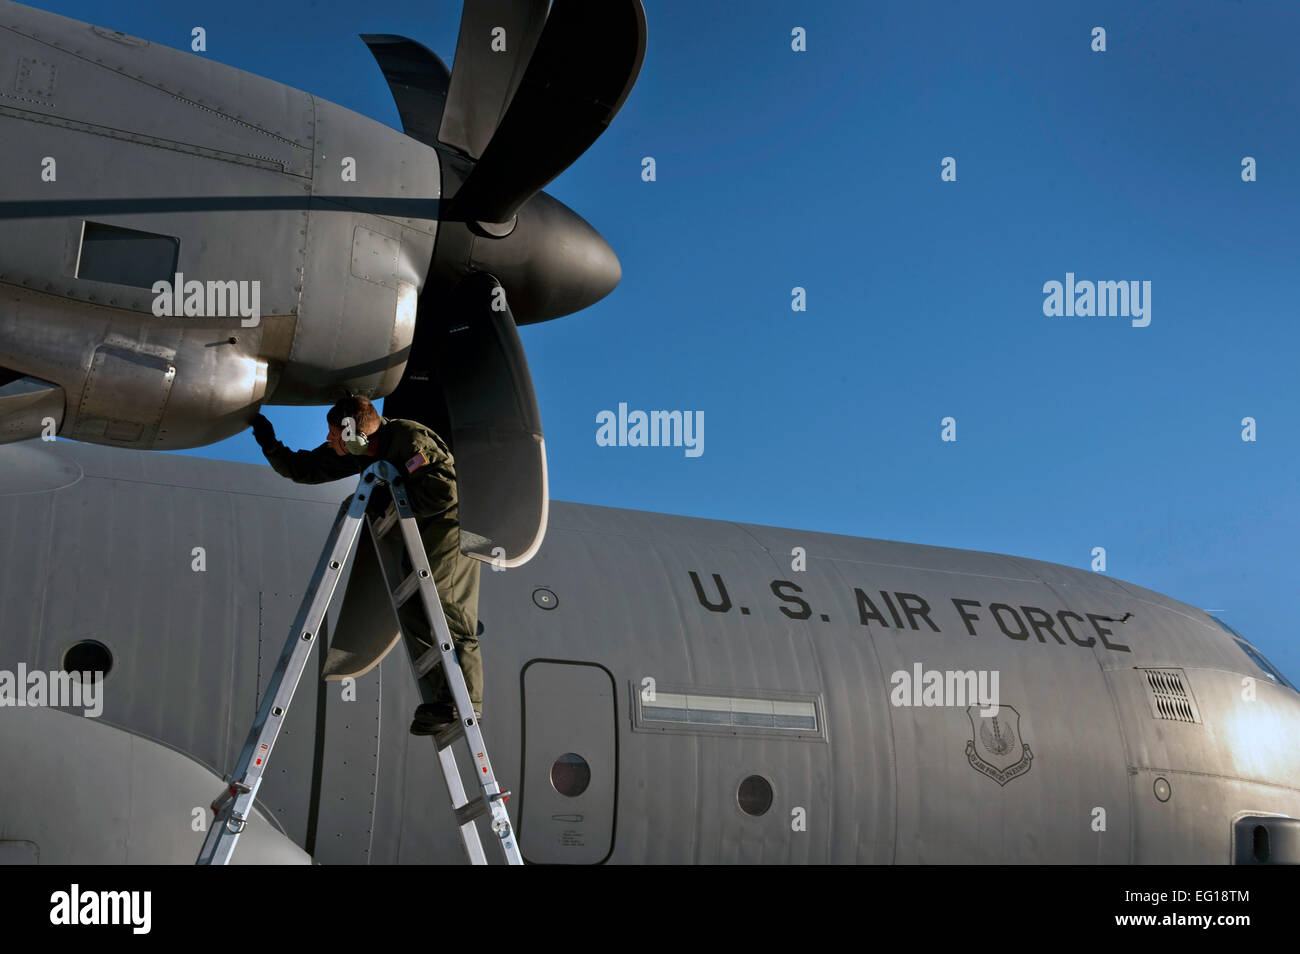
[0,441,1300,864]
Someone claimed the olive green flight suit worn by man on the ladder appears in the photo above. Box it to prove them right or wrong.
[264,417,484,710]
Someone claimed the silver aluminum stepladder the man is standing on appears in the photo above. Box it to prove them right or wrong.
[198,460,524,864]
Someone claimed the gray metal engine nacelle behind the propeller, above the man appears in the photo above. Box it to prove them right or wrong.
[0,4,441,450]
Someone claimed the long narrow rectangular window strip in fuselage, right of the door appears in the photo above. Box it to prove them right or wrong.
[632,684,826,738]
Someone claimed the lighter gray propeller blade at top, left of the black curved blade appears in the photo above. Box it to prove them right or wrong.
[438,0,550,159]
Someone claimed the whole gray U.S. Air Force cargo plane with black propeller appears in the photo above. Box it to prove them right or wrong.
[0,0,1300,864]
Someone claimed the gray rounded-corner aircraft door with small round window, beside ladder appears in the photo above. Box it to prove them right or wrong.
[519,659,619,864]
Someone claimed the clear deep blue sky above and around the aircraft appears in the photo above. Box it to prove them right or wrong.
[40,0,1300,680]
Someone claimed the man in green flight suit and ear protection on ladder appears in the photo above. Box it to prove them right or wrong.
[252,396,484,736]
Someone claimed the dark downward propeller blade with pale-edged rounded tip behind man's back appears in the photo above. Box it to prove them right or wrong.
[384,272,549,567]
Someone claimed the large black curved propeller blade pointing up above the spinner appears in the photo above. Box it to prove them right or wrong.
[443,0,646,222]
